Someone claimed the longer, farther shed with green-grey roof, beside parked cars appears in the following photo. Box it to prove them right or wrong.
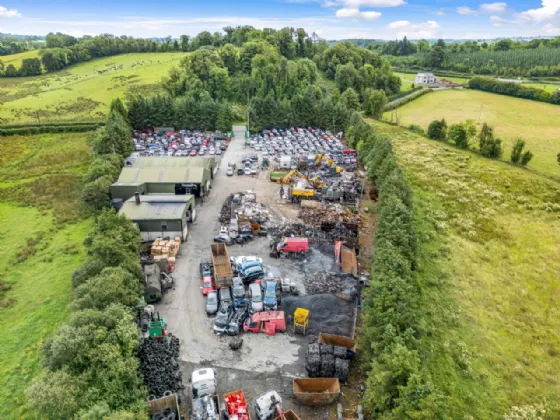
[111,164,212,200]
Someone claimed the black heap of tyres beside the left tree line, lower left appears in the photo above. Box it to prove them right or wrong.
[138,334,184,400]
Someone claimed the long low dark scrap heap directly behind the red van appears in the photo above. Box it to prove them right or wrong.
[268,222,357,244]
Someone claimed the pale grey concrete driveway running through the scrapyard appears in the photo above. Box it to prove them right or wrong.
[156,127,328,419]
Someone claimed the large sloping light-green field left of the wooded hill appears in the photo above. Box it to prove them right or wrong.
[0,53,184,125]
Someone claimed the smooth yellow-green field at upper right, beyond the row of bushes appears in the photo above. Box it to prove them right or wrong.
[384,90,560,178]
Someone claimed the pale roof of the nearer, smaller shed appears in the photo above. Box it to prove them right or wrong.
[119,194,195,221]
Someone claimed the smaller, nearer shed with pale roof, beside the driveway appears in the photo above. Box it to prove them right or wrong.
[119,194,196,242]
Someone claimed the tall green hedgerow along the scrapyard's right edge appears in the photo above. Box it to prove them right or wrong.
[346,112,445,418]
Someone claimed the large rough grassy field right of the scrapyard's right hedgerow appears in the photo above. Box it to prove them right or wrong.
[373,120,560,419]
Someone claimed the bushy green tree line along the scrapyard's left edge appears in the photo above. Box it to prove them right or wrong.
[28,101,147,419]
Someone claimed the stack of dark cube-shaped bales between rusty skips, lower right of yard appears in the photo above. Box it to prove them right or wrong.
[305,343,350,382]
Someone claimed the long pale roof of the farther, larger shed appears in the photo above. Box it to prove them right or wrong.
[117,167,209,184]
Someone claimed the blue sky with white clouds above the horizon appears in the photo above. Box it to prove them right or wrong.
[0,0,560,40]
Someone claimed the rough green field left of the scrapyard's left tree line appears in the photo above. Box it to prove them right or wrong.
[0,133,91,419]
